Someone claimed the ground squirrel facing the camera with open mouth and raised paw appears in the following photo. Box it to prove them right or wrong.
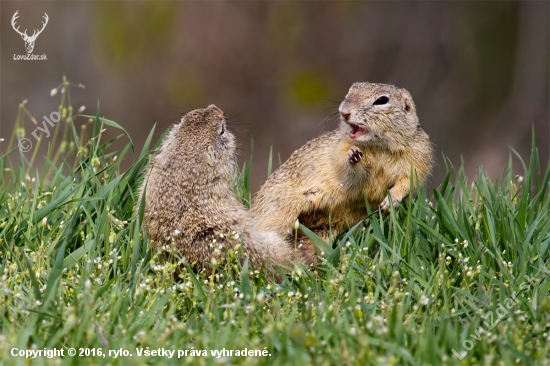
[251,83,433,264]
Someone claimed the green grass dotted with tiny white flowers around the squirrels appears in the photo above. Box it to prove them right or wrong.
[0,81,550,365]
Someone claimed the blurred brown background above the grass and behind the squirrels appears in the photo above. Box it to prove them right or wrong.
[0,1,550,191]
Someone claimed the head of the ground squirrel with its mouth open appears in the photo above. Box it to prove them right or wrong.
[338,83,420,148]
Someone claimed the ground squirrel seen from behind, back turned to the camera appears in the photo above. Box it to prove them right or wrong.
[141,105,292,273]
